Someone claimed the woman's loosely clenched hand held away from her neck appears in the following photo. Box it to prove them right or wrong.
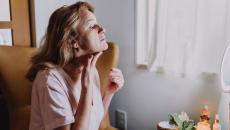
[107,68,124,94]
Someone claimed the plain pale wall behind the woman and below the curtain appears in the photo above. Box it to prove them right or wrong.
[35,0,227,130]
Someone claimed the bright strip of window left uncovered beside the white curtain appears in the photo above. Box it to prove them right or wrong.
[135,0,157,65]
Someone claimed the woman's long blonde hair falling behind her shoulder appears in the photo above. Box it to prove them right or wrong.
[26,1,94,81]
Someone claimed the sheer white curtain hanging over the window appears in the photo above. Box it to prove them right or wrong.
[146,0,230,76]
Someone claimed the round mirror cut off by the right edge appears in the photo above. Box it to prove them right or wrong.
[220,42,230,93]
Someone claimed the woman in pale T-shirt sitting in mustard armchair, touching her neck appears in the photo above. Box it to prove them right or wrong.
[27,2,124,130]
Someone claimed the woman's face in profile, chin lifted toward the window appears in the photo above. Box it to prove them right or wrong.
[77,9,108,54]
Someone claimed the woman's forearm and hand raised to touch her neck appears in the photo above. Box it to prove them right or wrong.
[55,53,101,130]
